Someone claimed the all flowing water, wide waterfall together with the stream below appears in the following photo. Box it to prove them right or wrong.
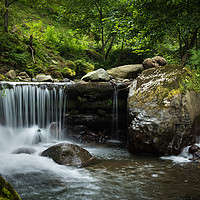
[0,82,200,200]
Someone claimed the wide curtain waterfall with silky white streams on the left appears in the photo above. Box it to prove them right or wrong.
[0,84,67,149]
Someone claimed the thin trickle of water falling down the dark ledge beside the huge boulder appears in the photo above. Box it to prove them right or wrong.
[112,84,119,137]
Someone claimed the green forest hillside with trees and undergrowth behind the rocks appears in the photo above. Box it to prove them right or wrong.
[0,0,200,89]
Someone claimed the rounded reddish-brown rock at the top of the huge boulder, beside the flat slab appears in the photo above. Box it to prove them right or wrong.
[142,56,167,69]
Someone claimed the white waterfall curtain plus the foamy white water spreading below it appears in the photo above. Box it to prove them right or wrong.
[0,84,96,199]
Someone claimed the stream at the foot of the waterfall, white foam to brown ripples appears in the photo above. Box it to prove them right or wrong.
[0,134,200,200]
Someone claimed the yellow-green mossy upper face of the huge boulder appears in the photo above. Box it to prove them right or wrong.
[129,65,183,114]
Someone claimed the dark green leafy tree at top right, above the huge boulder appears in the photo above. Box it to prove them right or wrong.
[131,0,200,65]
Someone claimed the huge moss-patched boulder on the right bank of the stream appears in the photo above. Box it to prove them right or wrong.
[128,66,200,155]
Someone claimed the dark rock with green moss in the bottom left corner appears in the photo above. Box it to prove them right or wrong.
[0,176,20,200]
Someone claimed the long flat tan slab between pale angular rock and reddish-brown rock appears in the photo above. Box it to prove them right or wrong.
[107,64,144,79]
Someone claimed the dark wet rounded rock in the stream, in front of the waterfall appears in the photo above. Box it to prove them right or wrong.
[41,143,97,167]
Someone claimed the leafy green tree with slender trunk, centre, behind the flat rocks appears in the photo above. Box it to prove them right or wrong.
[60,0,130,61]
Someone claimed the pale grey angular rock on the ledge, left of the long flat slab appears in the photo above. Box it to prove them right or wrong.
[81,68,110,81]
